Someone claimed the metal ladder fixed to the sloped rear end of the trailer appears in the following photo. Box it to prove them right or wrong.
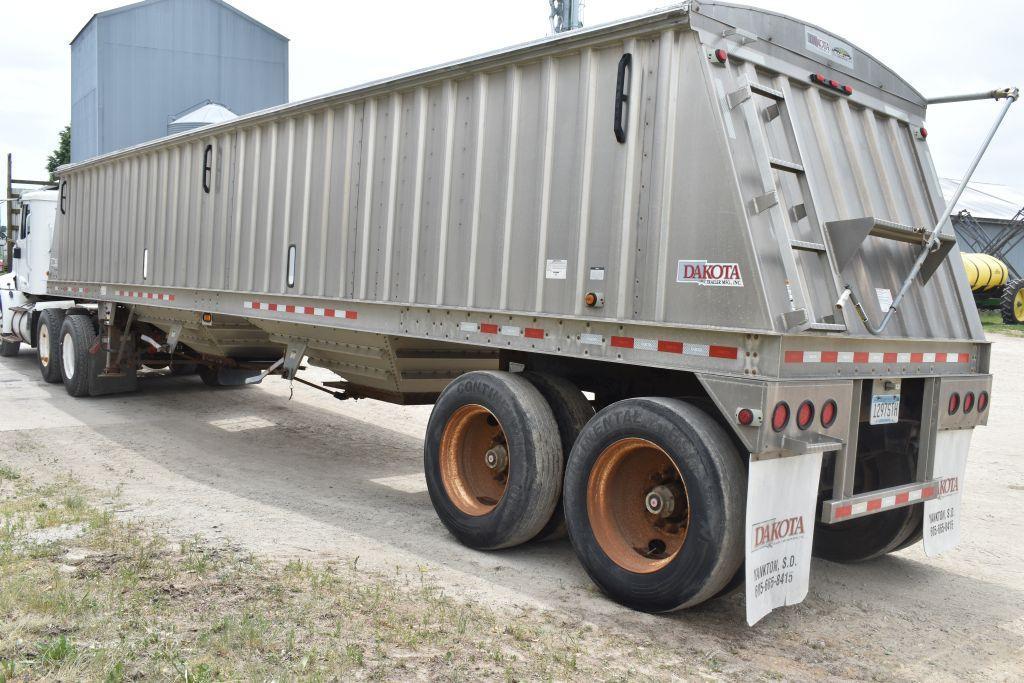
[727,78,847,332]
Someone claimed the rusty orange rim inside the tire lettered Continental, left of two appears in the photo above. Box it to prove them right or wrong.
[440,403,510,517]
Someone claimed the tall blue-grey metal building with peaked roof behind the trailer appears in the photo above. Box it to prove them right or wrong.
[72,0,288,162]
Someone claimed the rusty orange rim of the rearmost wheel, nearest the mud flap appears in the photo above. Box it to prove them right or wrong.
[587,438,690,573]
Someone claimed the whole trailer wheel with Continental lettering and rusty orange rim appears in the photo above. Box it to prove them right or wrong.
[423,371,563,550]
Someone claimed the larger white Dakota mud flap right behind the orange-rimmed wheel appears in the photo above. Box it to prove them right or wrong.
[745,453,821,626]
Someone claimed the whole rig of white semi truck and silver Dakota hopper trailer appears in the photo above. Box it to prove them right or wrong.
[0,2,1017,623]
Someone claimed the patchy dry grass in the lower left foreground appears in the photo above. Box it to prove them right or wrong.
[0,473,688,683]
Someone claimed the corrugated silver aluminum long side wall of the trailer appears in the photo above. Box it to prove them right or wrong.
[54,15,769,329]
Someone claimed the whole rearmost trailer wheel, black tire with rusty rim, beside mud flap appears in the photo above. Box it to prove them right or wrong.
[564,397,746,612]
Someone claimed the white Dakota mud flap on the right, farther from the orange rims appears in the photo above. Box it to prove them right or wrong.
[924,429,974,557]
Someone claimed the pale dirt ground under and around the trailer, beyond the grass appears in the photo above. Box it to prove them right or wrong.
[0,335,1024,681]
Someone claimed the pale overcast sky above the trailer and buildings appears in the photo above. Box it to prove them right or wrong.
[0,0,1024,194]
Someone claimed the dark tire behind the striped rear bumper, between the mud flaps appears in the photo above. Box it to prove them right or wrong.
[814,452,924,563]
